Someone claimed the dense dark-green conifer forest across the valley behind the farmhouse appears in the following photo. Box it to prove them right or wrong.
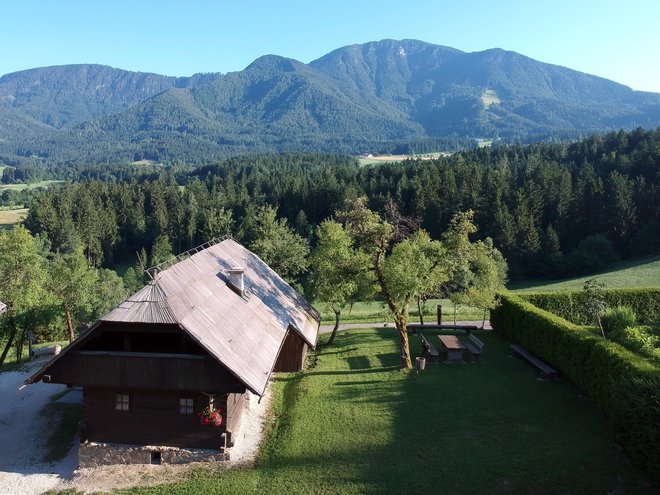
[11,129,660,279]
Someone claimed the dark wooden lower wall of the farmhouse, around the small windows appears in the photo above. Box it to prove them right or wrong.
[83,387,246,449]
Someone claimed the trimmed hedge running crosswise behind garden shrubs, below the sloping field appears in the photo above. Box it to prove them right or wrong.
[520,289,660,325]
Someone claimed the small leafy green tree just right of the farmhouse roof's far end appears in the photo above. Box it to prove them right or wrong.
[310,220,374,345]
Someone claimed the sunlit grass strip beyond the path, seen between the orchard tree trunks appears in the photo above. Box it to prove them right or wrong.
[314,299,484,324]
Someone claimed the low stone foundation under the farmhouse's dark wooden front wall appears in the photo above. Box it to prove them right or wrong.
[78,442,229,468]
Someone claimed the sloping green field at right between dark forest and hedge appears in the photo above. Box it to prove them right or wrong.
[509,256,660,292]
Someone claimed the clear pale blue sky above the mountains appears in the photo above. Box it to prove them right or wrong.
[5,0,660,92]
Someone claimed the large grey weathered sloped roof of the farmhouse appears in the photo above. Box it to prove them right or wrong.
[27,239,320,395]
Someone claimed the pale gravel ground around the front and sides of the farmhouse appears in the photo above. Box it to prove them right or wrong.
[0,359,271,495]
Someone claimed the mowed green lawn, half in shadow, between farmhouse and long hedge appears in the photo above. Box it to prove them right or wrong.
[121,329,654,495]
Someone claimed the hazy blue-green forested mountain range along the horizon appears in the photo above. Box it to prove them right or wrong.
[0,40,660,164]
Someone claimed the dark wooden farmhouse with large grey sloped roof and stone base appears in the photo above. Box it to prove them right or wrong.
[26,239,320,466]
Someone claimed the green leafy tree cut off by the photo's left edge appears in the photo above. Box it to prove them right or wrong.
[0,225,46,365]
